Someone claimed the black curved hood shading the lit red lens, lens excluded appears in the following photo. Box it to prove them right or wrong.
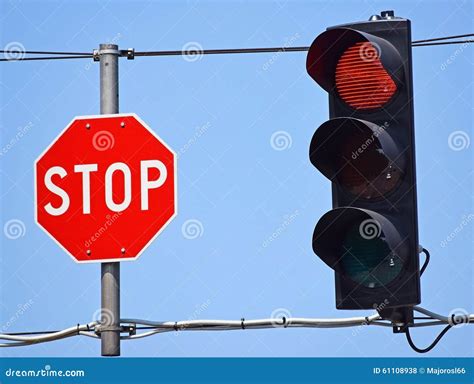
[306,28,404,93]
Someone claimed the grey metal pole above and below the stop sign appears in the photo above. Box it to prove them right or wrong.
[99,44,120,356]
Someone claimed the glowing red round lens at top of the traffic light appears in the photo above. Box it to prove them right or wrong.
[336,41,397,110]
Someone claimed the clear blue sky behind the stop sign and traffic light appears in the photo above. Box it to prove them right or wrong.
[0,0,474,356]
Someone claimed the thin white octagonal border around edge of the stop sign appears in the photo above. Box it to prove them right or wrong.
[34,113,178,264]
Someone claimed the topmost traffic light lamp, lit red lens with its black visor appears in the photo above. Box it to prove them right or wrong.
[306,28,403,110]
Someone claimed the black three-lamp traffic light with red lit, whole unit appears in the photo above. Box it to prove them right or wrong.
[306,11,420,321]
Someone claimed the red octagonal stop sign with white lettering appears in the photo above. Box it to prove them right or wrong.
[35,114,176,262]
